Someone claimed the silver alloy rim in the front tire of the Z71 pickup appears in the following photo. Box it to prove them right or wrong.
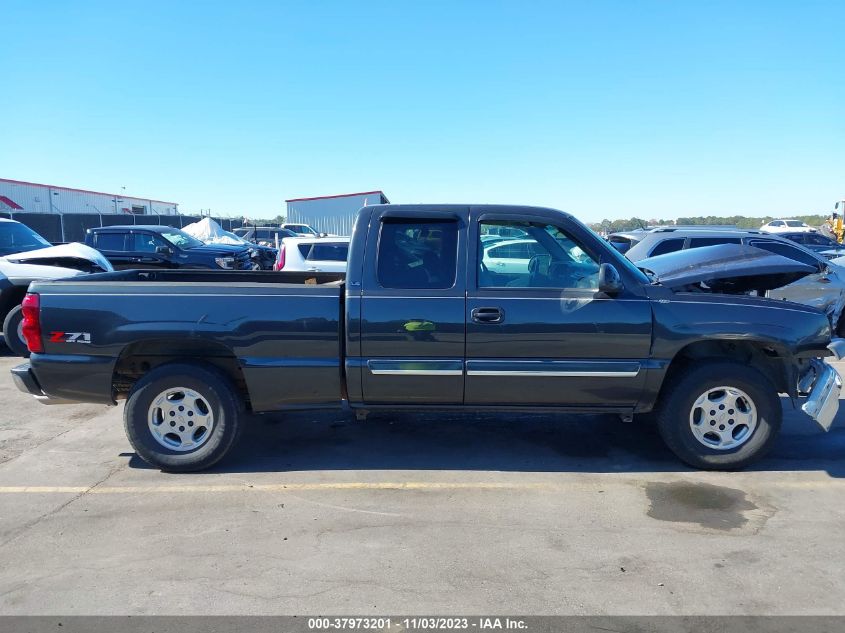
[690,387,757,451]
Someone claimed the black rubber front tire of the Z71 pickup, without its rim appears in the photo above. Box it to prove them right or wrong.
[656,360,783,470]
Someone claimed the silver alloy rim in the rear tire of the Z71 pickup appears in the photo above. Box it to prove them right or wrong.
[147,387,214,452]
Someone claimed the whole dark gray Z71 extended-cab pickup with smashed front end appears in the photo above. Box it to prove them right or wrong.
[12,205,845,471]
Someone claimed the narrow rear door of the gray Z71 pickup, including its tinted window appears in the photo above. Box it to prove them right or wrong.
[359,207,468,405]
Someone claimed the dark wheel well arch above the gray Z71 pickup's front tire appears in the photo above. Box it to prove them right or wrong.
[661,339,797,397]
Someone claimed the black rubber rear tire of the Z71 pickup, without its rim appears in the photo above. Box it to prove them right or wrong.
[123,362,244,472]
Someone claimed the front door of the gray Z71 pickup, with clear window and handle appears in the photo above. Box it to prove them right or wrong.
[464,211,651,408]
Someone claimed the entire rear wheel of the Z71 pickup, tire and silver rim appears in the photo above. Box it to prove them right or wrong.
[123,363,243,472]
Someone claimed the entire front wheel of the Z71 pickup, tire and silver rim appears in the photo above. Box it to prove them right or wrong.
[656,361,782,470]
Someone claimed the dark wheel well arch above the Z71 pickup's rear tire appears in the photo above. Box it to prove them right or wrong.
[112,338,249,404]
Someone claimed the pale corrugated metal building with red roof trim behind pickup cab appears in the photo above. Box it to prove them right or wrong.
[285,191,390,235]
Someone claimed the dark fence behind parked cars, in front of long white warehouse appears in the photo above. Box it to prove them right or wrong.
[0,212,243,244]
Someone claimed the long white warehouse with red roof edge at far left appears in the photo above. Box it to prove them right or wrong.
[0,178,179,215]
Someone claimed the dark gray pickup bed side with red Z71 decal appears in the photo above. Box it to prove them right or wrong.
[23,270,343,412]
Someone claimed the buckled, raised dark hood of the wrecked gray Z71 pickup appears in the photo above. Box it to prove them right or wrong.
[637,244,818,292]
